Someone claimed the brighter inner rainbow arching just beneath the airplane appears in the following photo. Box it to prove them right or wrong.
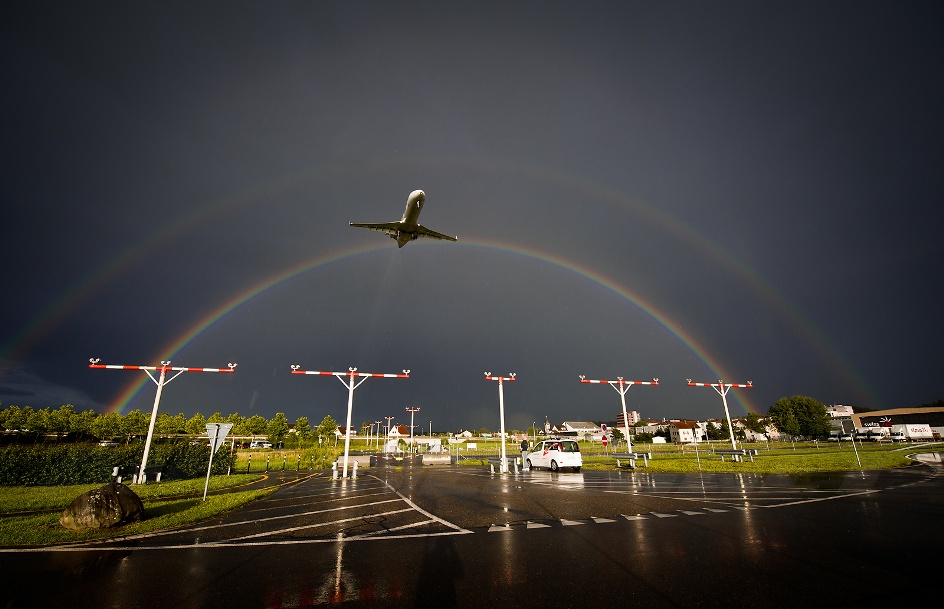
[108,239,759,413]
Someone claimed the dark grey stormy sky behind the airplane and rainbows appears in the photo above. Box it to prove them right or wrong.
[0,2,944,431]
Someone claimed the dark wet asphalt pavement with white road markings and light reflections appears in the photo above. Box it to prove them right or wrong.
[0,466,944,609]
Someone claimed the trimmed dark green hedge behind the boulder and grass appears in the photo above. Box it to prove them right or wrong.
[0,442,235,486]
